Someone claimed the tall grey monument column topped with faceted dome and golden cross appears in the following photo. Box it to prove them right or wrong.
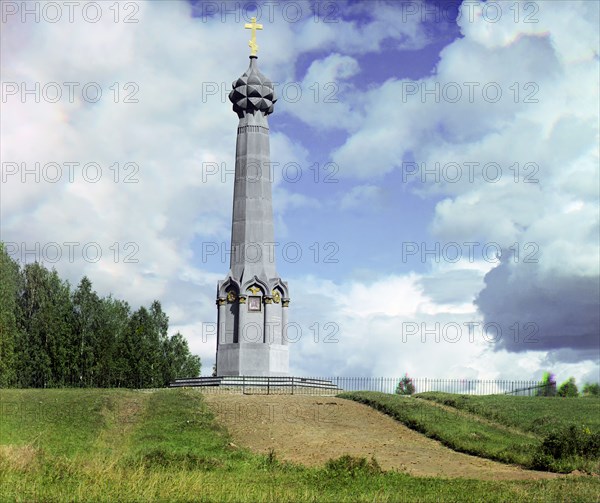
[217,18,290,376]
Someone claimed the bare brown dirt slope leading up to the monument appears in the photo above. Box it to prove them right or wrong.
[205,394,558,480]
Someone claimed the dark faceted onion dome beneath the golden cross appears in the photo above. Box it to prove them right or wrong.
[229,57,277,117]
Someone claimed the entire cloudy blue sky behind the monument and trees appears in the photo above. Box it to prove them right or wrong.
[0,0,600,382]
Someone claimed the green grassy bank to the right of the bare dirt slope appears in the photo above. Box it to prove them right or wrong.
[339,391,600,474]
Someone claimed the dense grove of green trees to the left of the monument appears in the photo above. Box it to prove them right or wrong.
[0,246,201,388]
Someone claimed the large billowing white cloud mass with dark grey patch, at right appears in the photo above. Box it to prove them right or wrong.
[322,2,600,370]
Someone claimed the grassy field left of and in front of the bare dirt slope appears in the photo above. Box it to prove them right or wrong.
[0,389,599,502]
